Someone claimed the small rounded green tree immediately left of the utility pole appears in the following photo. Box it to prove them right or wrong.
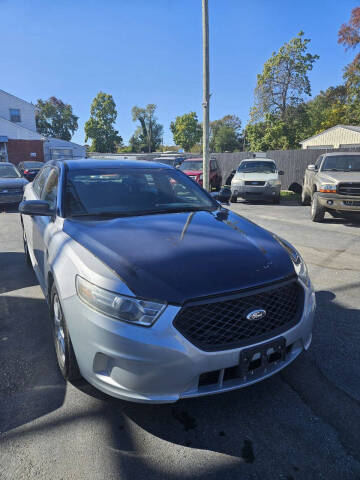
[170,112,202,152]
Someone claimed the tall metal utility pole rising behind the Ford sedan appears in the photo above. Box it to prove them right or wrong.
[202,0,210,191]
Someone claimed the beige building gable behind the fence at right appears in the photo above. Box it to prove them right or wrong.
[300,125,360,150]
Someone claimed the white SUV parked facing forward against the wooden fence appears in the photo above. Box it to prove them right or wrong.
[231,158,284,203]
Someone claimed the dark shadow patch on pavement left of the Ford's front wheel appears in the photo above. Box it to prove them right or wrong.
[0,294,66,433]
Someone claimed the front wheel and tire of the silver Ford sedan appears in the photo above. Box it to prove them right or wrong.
[50,284,81,382]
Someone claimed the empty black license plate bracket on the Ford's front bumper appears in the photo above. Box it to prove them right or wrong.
[239,337,286,378]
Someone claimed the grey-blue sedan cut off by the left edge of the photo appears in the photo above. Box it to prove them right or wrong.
[0,162,28,204]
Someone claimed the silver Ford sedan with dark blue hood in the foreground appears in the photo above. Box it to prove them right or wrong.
[19,159,315,403]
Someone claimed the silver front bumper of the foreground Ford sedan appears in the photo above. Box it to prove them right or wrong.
[62,280,315,403]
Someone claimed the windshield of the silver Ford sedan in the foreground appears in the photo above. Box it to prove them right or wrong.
[65,167,217,217]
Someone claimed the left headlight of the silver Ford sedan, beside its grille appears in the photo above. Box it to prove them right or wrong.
[76,275,166,327]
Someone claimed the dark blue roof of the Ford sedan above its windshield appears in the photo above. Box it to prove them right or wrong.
[57,158,171,170]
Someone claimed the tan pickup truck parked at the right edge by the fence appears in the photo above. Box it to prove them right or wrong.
[301,152,360,222]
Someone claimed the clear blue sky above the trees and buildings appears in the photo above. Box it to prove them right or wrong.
[0,0,358,144]
